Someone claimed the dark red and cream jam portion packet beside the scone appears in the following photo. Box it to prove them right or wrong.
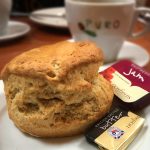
[100,60,150,110]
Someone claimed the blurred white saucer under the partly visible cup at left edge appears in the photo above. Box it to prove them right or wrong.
[0,21,30,42]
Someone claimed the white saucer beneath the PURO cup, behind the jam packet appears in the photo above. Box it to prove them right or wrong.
[68,39,150,70]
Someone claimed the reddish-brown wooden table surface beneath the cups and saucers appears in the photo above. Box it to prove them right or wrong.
[0,17,150,72]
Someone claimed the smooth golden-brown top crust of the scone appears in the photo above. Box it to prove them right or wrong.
[1,41,103,80]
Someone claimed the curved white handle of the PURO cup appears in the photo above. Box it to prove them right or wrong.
[129,7,150,38]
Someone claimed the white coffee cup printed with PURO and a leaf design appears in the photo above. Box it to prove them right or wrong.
[65,0,150,62]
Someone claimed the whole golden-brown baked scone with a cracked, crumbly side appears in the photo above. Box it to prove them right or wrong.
[2,41,113,137]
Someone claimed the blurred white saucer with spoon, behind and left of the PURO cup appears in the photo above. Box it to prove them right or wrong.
[30,7,68,28]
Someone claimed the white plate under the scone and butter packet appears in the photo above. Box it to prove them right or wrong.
[0,80,150,150]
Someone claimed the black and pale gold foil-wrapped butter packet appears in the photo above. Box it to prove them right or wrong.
[85,108,144,150]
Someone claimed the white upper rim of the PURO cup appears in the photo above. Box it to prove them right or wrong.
[66,0,135,6]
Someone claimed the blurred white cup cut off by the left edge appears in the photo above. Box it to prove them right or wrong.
[0,0,11,36]
